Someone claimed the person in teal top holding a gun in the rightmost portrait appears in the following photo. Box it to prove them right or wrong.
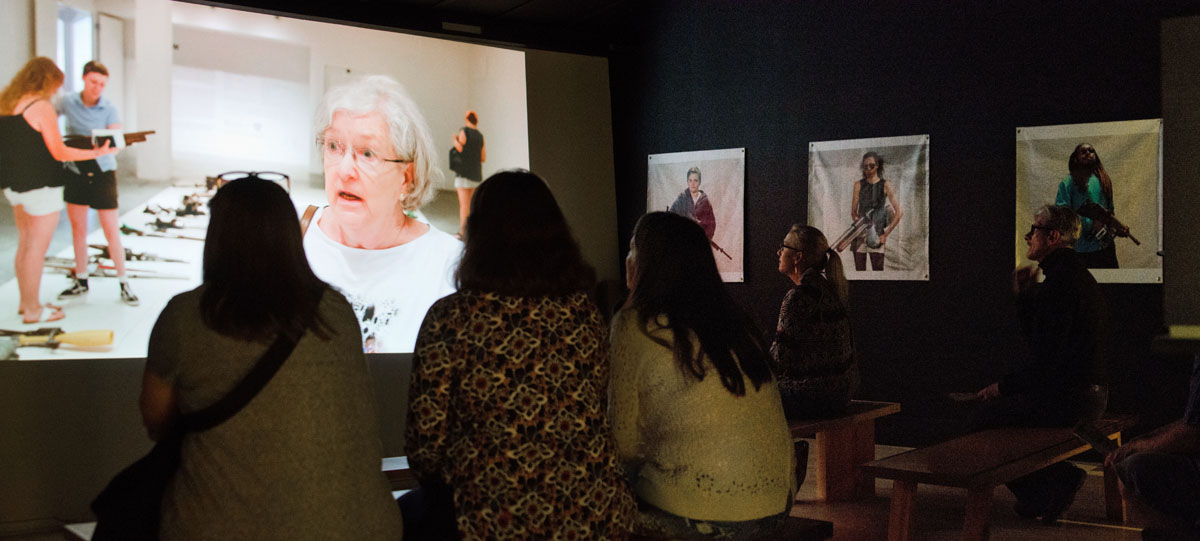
[1054,143,1129,269]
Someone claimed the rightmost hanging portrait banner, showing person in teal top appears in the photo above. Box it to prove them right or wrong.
[1014,119,1163,283]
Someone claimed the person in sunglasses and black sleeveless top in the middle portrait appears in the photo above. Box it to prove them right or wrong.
[850,151,904,271]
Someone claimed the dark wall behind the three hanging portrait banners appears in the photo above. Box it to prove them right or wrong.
[610,1,1188,445]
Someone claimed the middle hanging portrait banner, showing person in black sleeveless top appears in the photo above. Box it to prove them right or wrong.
[809,136,929,281]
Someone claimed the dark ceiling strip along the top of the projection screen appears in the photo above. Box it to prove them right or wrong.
[179,0,641,55]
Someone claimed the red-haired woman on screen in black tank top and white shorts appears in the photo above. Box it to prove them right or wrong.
[0,56,116,325]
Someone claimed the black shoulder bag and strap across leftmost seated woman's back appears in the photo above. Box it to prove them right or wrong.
[91,333,296,541]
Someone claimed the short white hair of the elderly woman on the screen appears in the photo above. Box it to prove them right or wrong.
[314,76,442,211]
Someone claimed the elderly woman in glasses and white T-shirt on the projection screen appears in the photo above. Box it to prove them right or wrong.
[304,76,462,351]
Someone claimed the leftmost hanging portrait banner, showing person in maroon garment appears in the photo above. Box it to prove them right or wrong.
[646,149,746,282]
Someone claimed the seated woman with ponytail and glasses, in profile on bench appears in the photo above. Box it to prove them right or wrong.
[770,223,858,419]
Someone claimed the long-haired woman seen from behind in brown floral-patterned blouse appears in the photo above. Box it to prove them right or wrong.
[400,170,638,540]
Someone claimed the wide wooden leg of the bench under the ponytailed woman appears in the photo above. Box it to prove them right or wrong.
[816,422,875,501]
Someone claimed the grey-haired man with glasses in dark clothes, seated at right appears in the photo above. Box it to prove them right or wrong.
[977,205,1108,524]
